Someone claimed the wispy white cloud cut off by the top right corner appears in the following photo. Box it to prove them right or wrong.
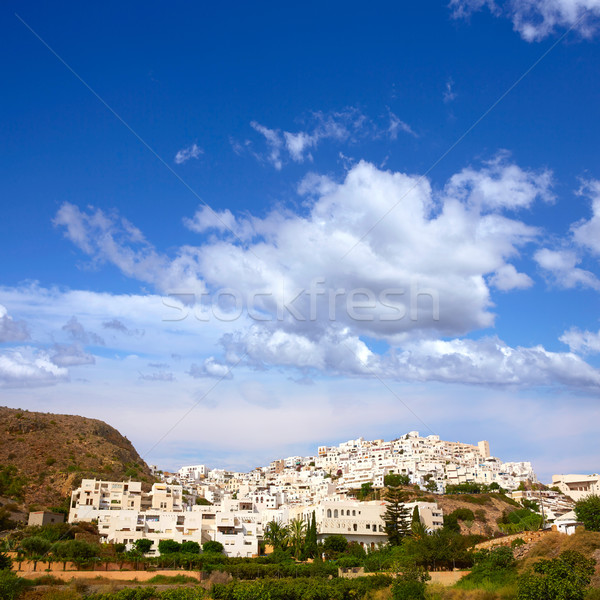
[450,0,600,42]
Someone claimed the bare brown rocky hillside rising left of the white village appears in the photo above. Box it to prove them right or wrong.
[0,407,153,508]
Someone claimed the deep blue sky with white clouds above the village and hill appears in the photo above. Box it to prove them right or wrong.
[0,0,600,479]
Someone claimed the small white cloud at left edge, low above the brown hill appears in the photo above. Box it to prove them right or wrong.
[0,348,69,387]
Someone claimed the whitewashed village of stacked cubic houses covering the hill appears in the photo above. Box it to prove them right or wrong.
[69,431,548,557]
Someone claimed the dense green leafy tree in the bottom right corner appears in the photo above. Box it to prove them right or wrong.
[518,550,596,600]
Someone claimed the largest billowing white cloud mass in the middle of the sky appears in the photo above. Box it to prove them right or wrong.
[54,154,597,387]
